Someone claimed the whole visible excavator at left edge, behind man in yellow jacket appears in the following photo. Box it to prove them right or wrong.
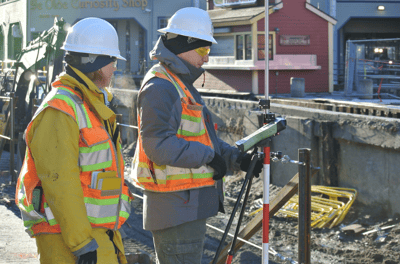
[0,18,67,173]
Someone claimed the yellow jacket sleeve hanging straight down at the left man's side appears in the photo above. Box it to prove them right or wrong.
[27,108,98,256]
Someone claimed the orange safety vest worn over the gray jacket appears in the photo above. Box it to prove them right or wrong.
[132,64,215,192]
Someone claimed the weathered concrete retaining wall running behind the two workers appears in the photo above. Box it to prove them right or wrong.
[112,89,400,216]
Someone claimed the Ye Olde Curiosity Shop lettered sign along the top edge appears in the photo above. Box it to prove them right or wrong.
[30,0,147,11]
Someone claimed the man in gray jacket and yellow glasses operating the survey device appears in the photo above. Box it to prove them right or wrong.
[132,7,262,264]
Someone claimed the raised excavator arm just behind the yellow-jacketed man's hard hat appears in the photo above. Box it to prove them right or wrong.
[11,18,67,131]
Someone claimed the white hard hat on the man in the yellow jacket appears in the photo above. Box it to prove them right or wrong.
[61,17,126,60]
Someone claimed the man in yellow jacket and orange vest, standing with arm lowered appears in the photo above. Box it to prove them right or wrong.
[16,18,132,264]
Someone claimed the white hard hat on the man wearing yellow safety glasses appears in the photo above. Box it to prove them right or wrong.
[158,7,217,44]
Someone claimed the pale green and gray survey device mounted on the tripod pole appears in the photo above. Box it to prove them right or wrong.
[235,117,286,152]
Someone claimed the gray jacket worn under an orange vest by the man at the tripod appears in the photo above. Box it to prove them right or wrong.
[138,38,240,230]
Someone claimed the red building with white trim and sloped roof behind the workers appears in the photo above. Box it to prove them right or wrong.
[196,0,336,94]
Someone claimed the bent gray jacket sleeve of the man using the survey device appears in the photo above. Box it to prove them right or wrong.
[138,78,214,168]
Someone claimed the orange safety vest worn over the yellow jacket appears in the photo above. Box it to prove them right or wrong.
[15,81,132,237]
